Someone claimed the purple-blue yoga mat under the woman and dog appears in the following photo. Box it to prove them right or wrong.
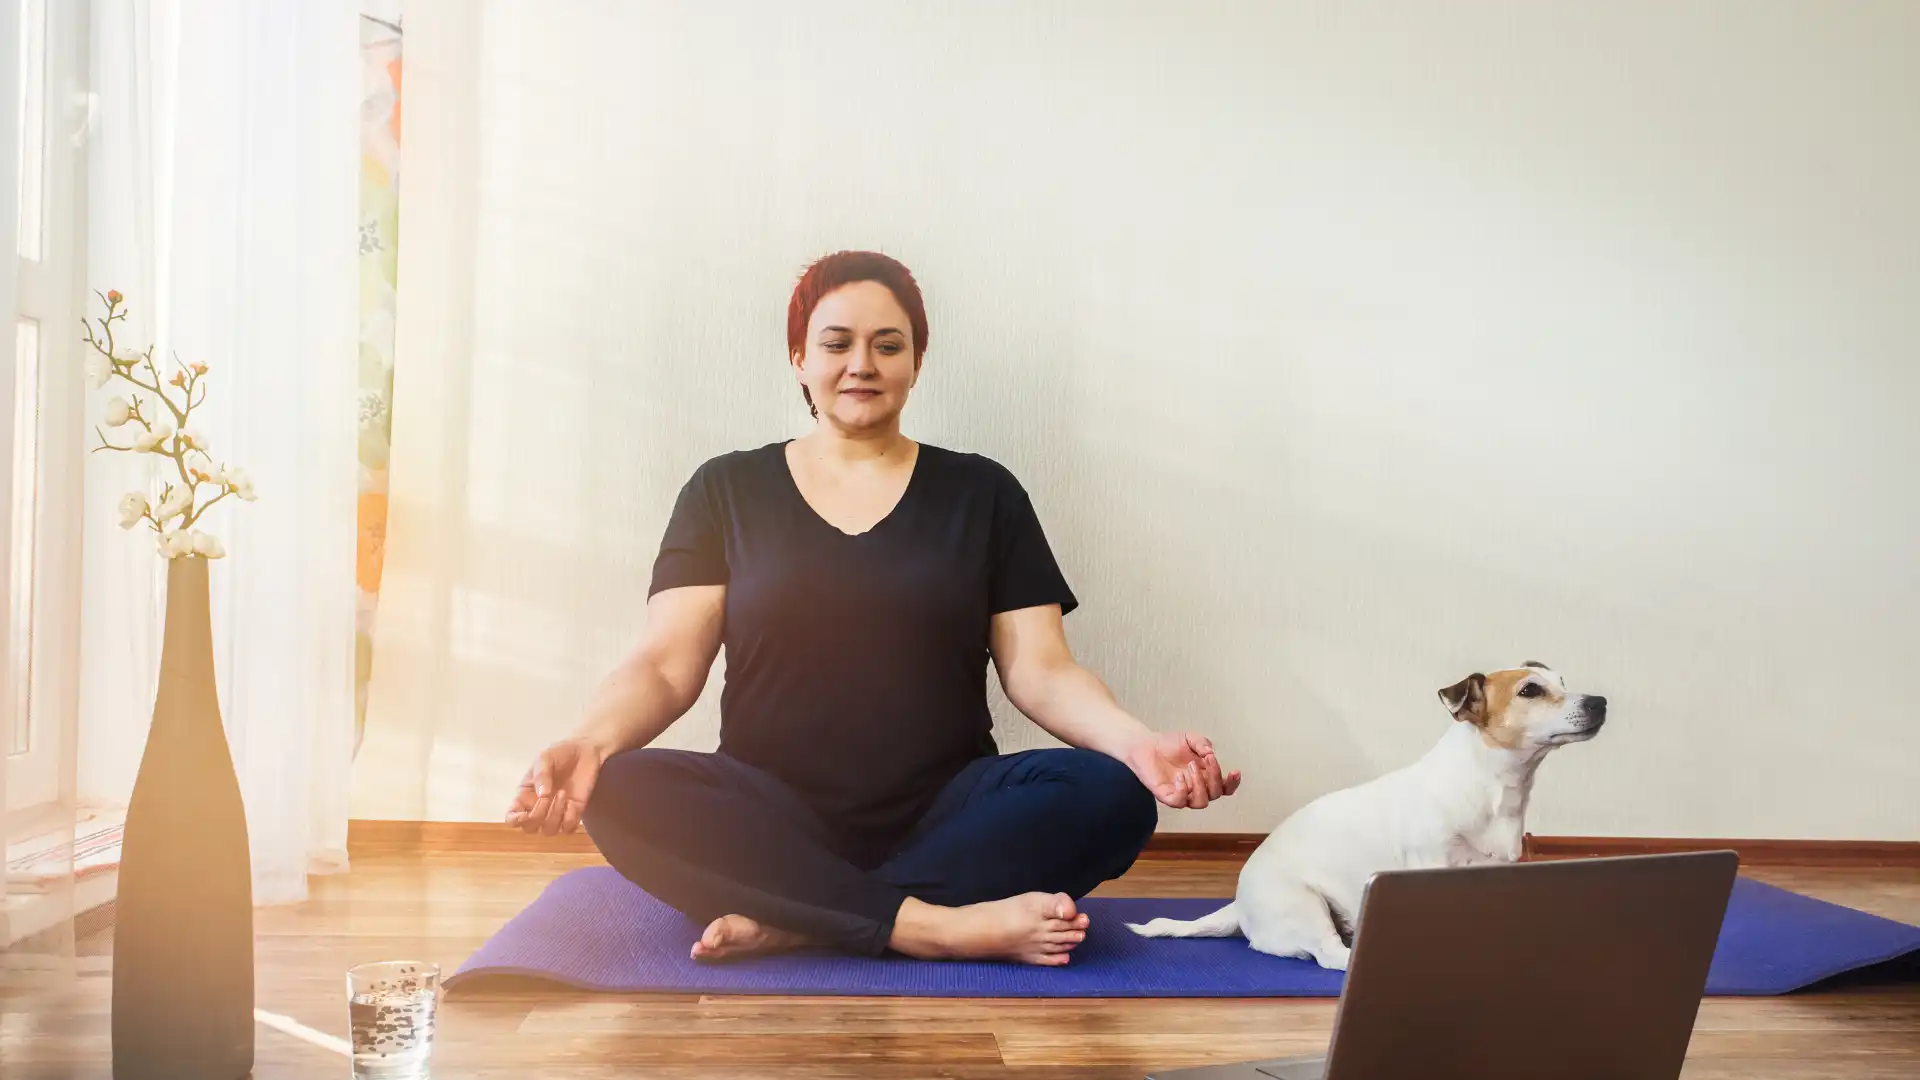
[447,867,1920,997]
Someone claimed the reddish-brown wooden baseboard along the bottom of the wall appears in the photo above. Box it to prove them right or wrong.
[348,821,1920,867]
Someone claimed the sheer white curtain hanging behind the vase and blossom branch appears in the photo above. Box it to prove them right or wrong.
[81,0,359,903]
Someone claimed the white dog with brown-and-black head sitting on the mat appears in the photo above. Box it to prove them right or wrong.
[1129,661,1607,970]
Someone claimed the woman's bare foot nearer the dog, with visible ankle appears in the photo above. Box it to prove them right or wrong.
[891,892,1087,967]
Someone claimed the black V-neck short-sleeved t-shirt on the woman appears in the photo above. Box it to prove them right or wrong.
[649,442,1077,847]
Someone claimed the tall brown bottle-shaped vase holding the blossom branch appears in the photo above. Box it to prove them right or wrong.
[113,555,253,1080]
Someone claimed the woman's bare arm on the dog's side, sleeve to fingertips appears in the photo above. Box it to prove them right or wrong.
[991,603,1240,809]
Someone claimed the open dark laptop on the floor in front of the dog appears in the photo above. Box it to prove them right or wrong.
[1150,851,1740,1080]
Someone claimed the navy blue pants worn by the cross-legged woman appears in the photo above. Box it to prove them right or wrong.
[584,749,1160,955]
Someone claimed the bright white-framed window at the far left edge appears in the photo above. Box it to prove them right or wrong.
[0,0,90,811]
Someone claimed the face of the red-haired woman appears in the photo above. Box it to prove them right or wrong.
[793,281,920,430]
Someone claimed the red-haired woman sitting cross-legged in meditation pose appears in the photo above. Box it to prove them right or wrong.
[507,252,1240,965]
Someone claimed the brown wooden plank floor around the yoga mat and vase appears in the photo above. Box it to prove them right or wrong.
[0,853,1920,1080]
